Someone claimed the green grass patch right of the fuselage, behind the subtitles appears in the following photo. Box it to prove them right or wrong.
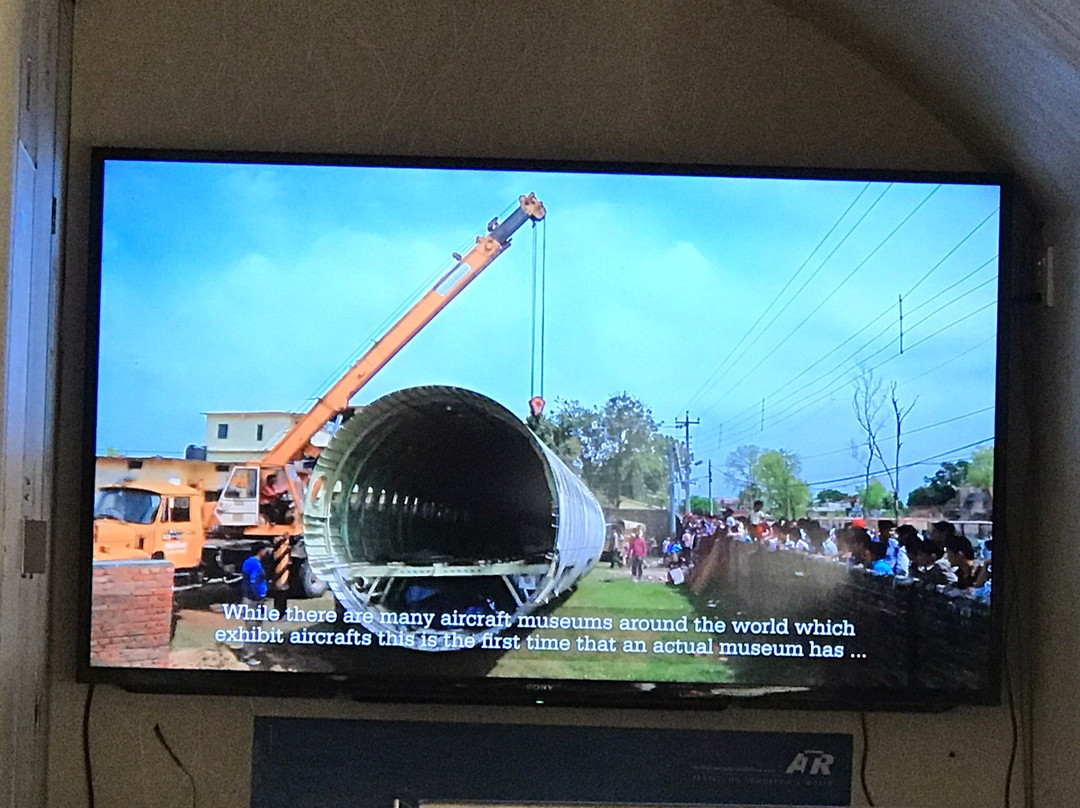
[490,568,732,683]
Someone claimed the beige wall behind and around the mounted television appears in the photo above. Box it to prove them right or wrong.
[49,0,1036,808]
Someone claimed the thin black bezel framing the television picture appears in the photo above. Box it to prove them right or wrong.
[78,146,1016,712]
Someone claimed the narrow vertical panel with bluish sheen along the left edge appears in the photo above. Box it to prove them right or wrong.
[0,0,70,806]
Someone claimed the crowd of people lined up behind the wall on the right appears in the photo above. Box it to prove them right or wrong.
[612,501,994,600]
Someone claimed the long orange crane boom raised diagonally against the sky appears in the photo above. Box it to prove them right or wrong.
[261,193,545,466]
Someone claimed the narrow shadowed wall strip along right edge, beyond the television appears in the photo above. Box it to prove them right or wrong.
[1016,214,1080,808]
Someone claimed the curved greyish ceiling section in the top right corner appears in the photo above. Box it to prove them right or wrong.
[771,0,1080,212]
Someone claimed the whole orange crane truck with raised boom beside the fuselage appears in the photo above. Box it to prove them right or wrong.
[94,193,546,597]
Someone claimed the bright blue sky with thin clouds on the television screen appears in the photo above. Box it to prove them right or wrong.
[97,161,999,495]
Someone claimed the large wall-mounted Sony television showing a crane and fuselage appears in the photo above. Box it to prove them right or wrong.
[80,149,1007,708]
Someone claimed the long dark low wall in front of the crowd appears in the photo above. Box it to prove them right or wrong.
[689,541,993,689]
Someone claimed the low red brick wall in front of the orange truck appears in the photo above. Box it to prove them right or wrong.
[90,561,173,668]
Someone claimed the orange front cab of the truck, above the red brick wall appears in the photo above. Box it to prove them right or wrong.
[94,481,206,569]
